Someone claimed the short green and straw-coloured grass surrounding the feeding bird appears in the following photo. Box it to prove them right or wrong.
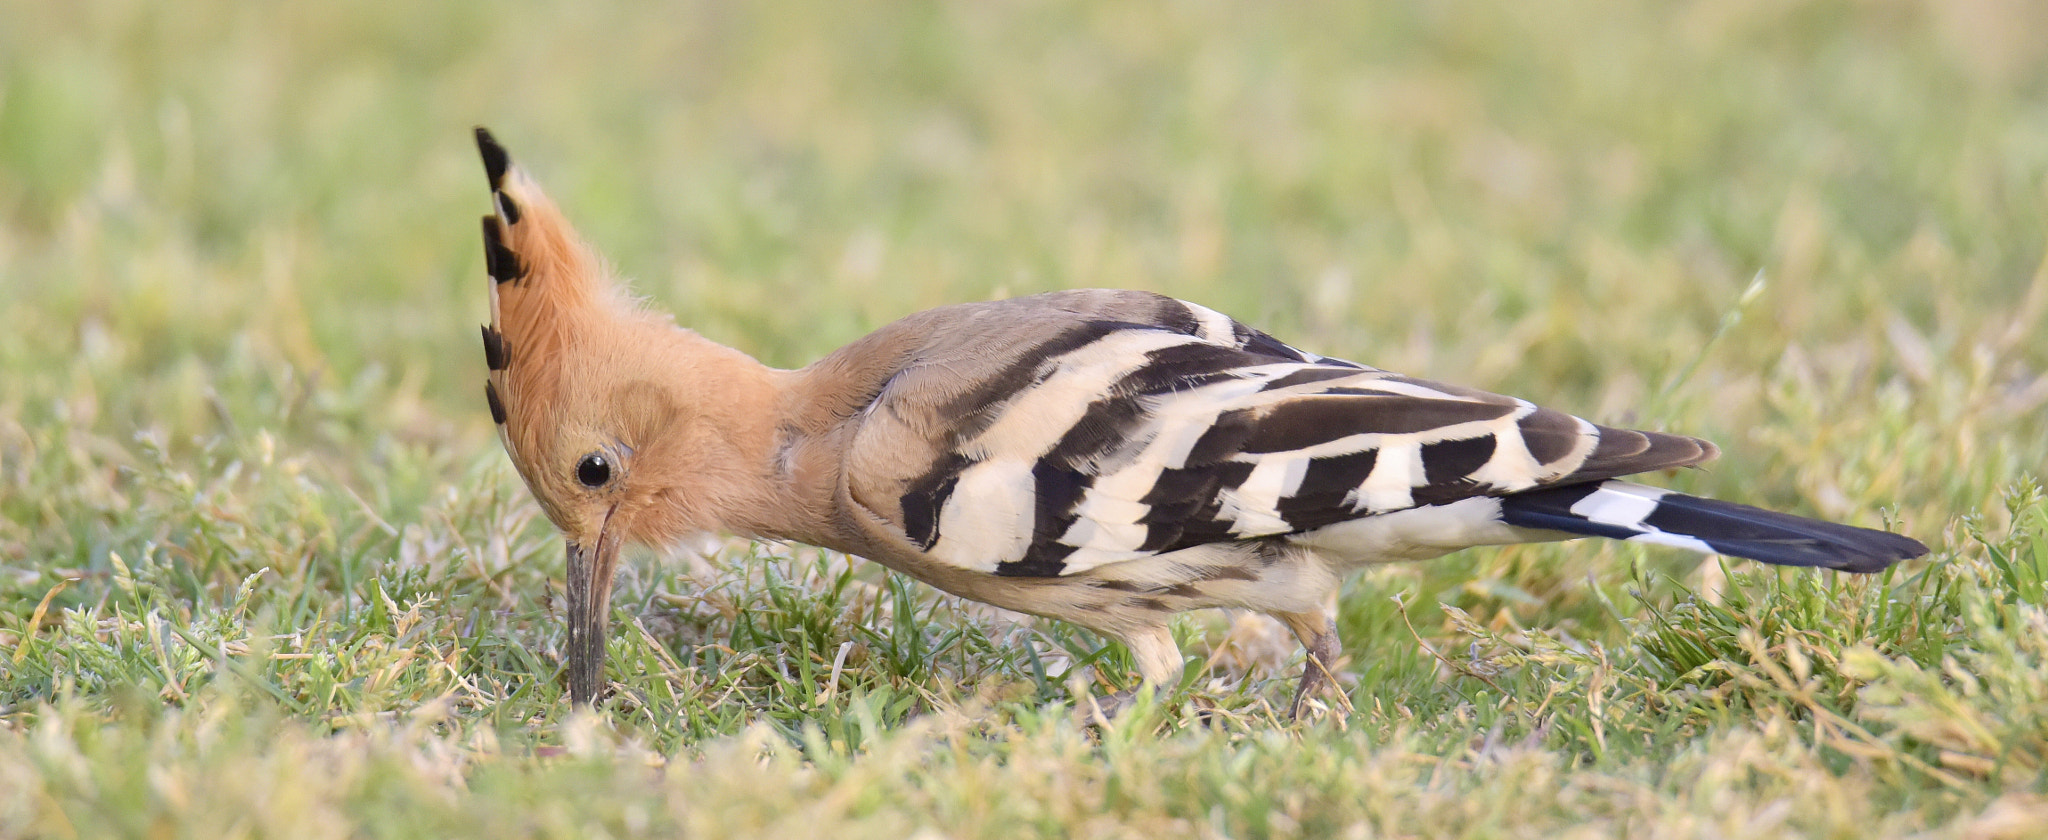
[0,0,2048,838]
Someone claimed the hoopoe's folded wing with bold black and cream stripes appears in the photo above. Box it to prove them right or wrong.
[879,320,1714,576]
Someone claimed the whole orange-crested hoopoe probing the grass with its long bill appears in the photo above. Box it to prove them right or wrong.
[477,127,1927,713]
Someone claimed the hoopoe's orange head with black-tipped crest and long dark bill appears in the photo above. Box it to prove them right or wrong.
[477,127,717,703]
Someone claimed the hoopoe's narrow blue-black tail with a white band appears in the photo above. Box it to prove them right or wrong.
[1501,479,1927,572]
